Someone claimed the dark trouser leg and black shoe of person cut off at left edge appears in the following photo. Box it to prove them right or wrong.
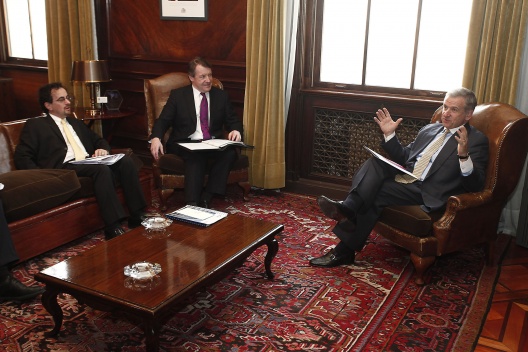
[0,202,44,302]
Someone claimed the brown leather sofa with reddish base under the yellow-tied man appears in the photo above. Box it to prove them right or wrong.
[0,119,152,261]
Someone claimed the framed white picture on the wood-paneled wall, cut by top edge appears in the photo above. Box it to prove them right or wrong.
[160,0,208,21]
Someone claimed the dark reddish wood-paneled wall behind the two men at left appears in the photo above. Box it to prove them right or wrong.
[0,0,247,162]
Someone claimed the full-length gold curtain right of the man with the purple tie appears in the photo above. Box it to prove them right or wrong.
[244,0,286,189]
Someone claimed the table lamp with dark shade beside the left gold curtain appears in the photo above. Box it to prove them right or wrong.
[71,60,110,116]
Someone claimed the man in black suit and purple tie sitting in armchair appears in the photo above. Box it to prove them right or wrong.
[150,57,243,208]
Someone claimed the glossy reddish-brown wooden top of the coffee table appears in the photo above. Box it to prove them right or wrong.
[35,214,284,312]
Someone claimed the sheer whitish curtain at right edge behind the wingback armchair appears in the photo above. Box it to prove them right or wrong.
[499,22,528,236]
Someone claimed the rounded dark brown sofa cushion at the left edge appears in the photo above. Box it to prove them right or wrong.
[0,169,81,222]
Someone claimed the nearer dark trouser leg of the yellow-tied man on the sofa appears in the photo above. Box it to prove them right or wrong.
[64,163,126,227]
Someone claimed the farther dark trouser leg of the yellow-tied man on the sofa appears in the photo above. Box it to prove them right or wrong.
[110,155,147,216]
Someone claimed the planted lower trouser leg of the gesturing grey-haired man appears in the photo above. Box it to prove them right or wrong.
[332,179,423,251]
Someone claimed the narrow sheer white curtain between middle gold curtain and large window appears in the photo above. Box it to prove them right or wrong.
[284,0,300,128]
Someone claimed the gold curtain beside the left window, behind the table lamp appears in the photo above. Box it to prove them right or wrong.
[46,0,100,125]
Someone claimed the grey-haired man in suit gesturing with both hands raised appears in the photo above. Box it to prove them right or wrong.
[310,88,488,267]
